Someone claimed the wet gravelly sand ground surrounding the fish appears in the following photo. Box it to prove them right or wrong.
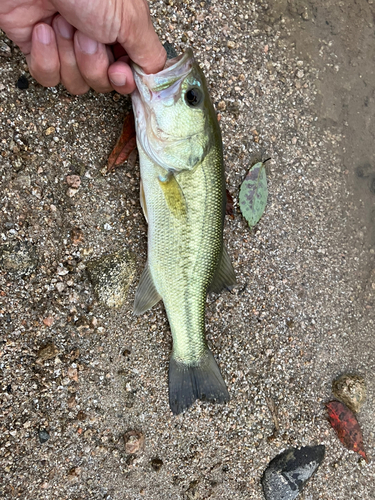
[0,0,375,500]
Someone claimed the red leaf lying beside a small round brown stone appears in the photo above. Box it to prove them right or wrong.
[326,401,368,462]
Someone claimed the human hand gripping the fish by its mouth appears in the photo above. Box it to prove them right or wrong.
[0,0,166,94]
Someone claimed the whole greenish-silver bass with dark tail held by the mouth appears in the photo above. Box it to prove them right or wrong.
[131,48,236,414]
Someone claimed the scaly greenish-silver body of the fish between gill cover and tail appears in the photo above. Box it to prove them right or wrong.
[140,143,224,363]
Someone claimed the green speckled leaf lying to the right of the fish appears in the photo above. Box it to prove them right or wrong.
[240,162,268,228]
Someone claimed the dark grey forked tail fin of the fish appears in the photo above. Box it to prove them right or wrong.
[169,349,229,415]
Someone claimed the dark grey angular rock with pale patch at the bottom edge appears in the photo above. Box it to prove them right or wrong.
[262,445,325,500]
